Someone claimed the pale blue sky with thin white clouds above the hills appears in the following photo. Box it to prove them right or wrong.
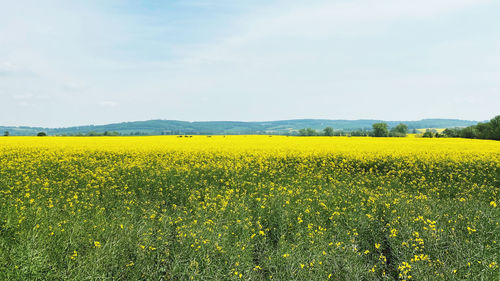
[0,0,500,127]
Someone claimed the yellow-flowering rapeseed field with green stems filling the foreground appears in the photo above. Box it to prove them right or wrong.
[0,136,500,280]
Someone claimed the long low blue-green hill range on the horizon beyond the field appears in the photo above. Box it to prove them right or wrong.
[0,119,478,136]
